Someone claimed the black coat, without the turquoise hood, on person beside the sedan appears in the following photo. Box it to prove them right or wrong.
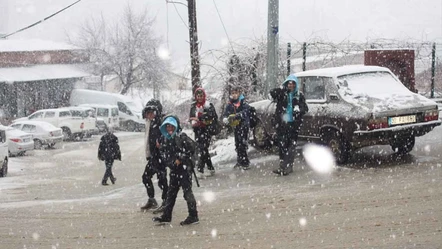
[270,88,308,128]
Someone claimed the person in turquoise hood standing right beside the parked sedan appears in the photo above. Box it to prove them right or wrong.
[270,75,308,175]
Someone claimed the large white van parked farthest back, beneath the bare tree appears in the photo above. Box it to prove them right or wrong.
[70,89,145,131]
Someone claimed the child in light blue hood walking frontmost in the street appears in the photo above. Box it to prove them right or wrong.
[152,116,199,226]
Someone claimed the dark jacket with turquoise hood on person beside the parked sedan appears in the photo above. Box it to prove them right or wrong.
[270,75,308,127]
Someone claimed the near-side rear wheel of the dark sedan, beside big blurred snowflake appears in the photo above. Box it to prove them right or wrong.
[321,130,351,164]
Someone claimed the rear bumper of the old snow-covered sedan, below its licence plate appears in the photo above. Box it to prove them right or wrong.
[352,120,442,146]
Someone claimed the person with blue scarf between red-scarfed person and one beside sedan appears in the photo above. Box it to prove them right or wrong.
[223,86,250,170]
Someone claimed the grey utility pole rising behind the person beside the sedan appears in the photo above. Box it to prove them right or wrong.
[265,0,279,94]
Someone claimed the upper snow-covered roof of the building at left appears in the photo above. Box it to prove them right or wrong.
[0,39,80,52]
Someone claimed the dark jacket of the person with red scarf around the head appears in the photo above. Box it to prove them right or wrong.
[189,88,218,129]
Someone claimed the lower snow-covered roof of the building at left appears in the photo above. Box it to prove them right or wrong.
[0,64,89,83]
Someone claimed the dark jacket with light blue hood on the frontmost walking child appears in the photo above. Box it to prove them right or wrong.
[160,115,195,172]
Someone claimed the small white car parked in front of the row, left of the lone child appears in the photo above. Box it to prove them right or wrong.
[10,121,63,149]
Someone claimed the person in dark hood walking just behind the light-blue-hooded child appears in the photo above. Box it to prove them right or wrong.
[141,99,168,213]
